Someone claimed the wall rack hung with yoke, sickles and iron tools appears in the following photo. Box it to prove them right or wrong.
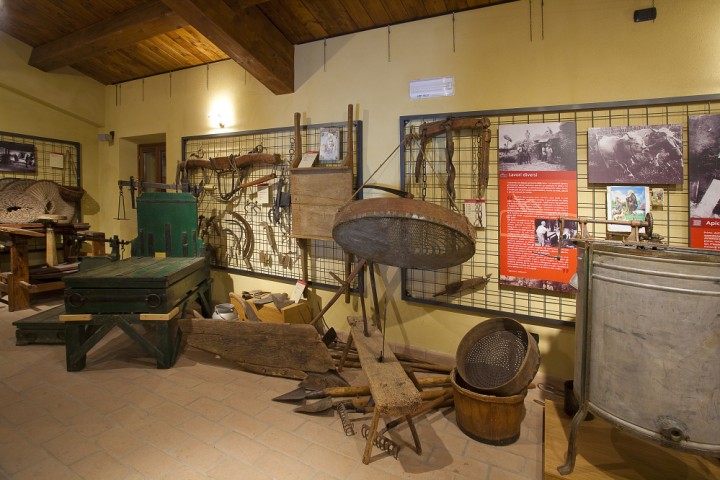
[178,116,362,288]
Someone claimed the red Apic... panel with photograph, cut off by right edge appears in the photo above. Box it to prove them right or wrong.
[688,115,720,250]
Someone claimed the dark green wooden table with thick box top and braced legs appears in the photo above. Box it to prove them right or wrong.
[60,257,211,372]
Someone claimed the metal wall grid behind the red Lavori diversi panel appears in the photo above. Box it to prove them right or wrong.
[400,95,720,325]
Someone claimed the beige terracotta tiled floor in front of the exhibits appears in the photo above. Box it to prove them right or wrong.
[0,301,543,480]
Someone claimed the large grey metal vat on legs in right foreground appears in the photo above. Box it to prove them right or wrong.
[559,241,720,474]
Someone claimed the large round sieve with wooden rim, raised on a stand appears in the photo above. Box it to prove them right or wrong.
[332,197,475,270]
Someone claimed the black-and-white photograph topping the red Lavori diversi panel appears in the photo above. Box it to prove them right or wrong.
[498,122,577,171]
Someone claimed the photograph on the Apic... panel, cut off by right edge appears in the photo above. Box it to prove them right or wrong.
[688,115,720,218]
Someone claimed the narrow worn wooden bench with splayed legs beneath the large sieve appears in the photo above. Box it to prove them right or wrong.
[348,317,422,465]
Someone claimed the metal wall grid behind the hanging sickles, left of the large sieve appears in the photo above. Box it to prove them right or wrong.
[182,121,362,289]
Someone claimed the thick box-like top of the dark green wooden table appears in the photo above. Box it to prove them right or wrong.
[63,257,210,314]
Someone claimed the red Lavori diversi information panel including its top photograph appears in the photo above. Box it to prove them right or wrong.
[499,123,578,292]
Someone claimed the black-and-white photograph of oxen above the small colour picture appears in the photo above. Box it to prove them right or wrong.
[588,124,683,185]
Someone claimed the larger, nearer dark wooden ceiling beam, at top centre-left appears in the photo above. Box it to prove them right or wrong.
[163,0,295,95]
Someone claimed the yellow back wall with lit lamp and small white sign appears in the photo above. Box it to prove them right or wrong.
[0,0,720,378]
